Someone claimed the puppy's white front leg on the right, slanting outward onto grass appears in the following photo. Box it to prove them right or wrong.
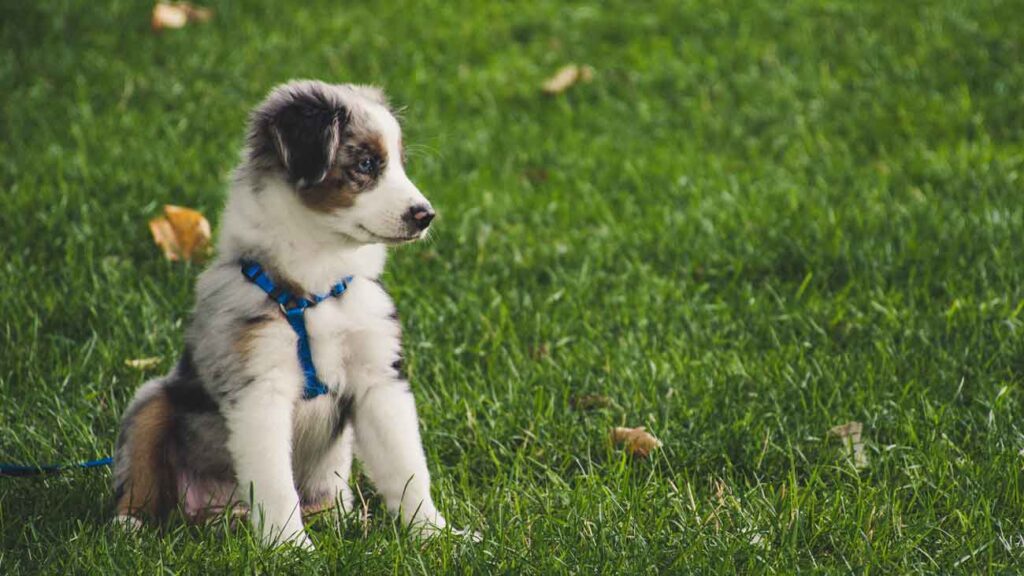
[354,381,446,533]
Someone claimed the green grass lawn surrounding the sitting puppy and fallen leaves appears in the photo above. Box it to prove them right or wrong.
[0,0,1024,574]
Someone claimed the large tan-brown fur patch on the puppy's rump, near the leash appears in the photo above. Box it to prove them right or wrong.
[117,392,177,520]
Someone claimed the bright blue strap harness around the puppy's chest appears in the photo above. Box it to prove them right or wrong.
[242,260,352,400]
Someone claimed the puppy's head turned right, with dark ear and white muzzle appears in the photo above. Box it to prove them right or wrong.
[249,81,434,244]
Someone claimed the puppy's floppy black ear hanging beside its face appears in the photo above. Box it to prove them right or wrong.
[267,93,346,188]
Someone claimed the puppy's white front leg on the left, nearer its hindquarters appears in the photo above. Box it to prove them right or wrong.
[225,381,312,548]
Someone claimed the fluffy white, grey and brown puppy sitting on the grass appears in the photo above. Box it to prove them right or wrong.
[114,81,456,547]
